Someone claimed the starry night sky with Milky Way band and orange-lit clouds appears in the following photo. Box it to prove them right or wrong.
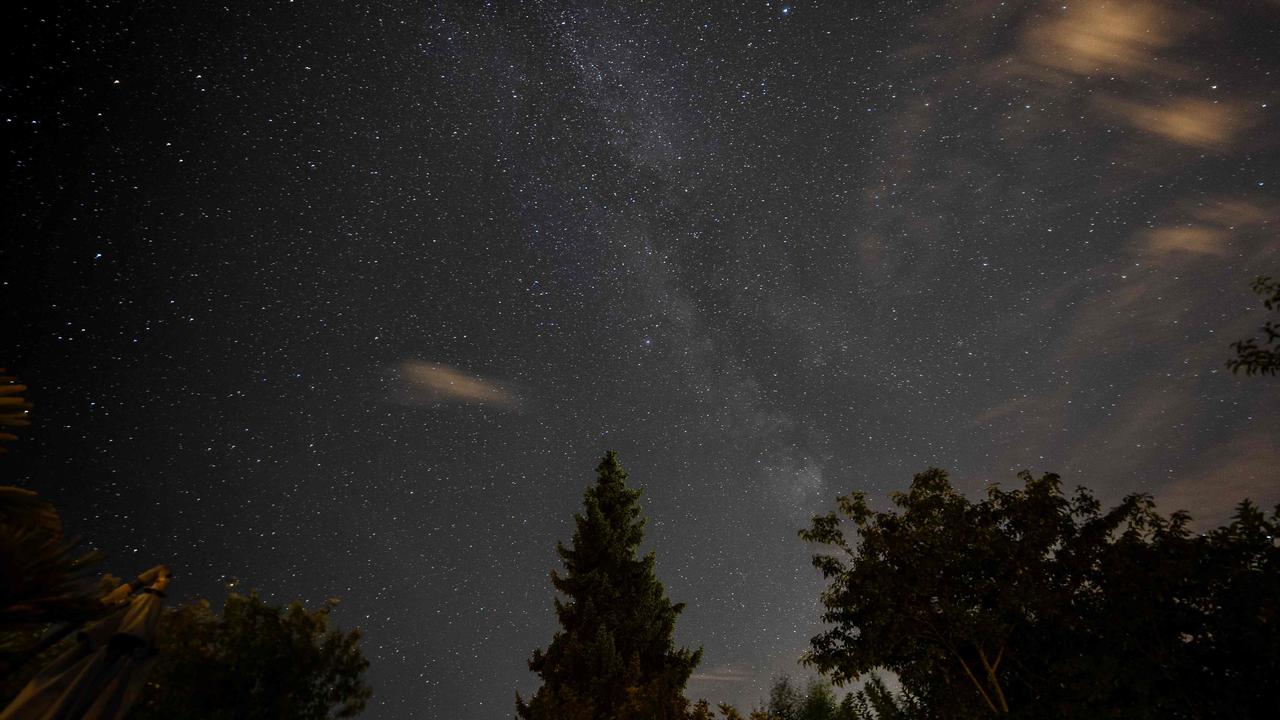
[0,0,1280,720]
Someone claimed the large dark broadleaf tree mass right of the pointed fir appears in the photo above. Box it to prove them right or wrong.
[800,469,1280,717]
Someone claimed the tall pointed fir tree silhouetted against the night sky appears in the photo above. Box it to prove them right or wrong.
[516,451,703,720]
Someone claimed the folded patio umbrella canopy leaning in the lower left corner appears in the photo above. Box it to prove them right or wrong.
[0,565,169,720]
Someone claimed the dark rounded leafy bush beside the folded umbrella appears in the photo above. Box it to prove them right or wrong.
[129,592,372,720]
